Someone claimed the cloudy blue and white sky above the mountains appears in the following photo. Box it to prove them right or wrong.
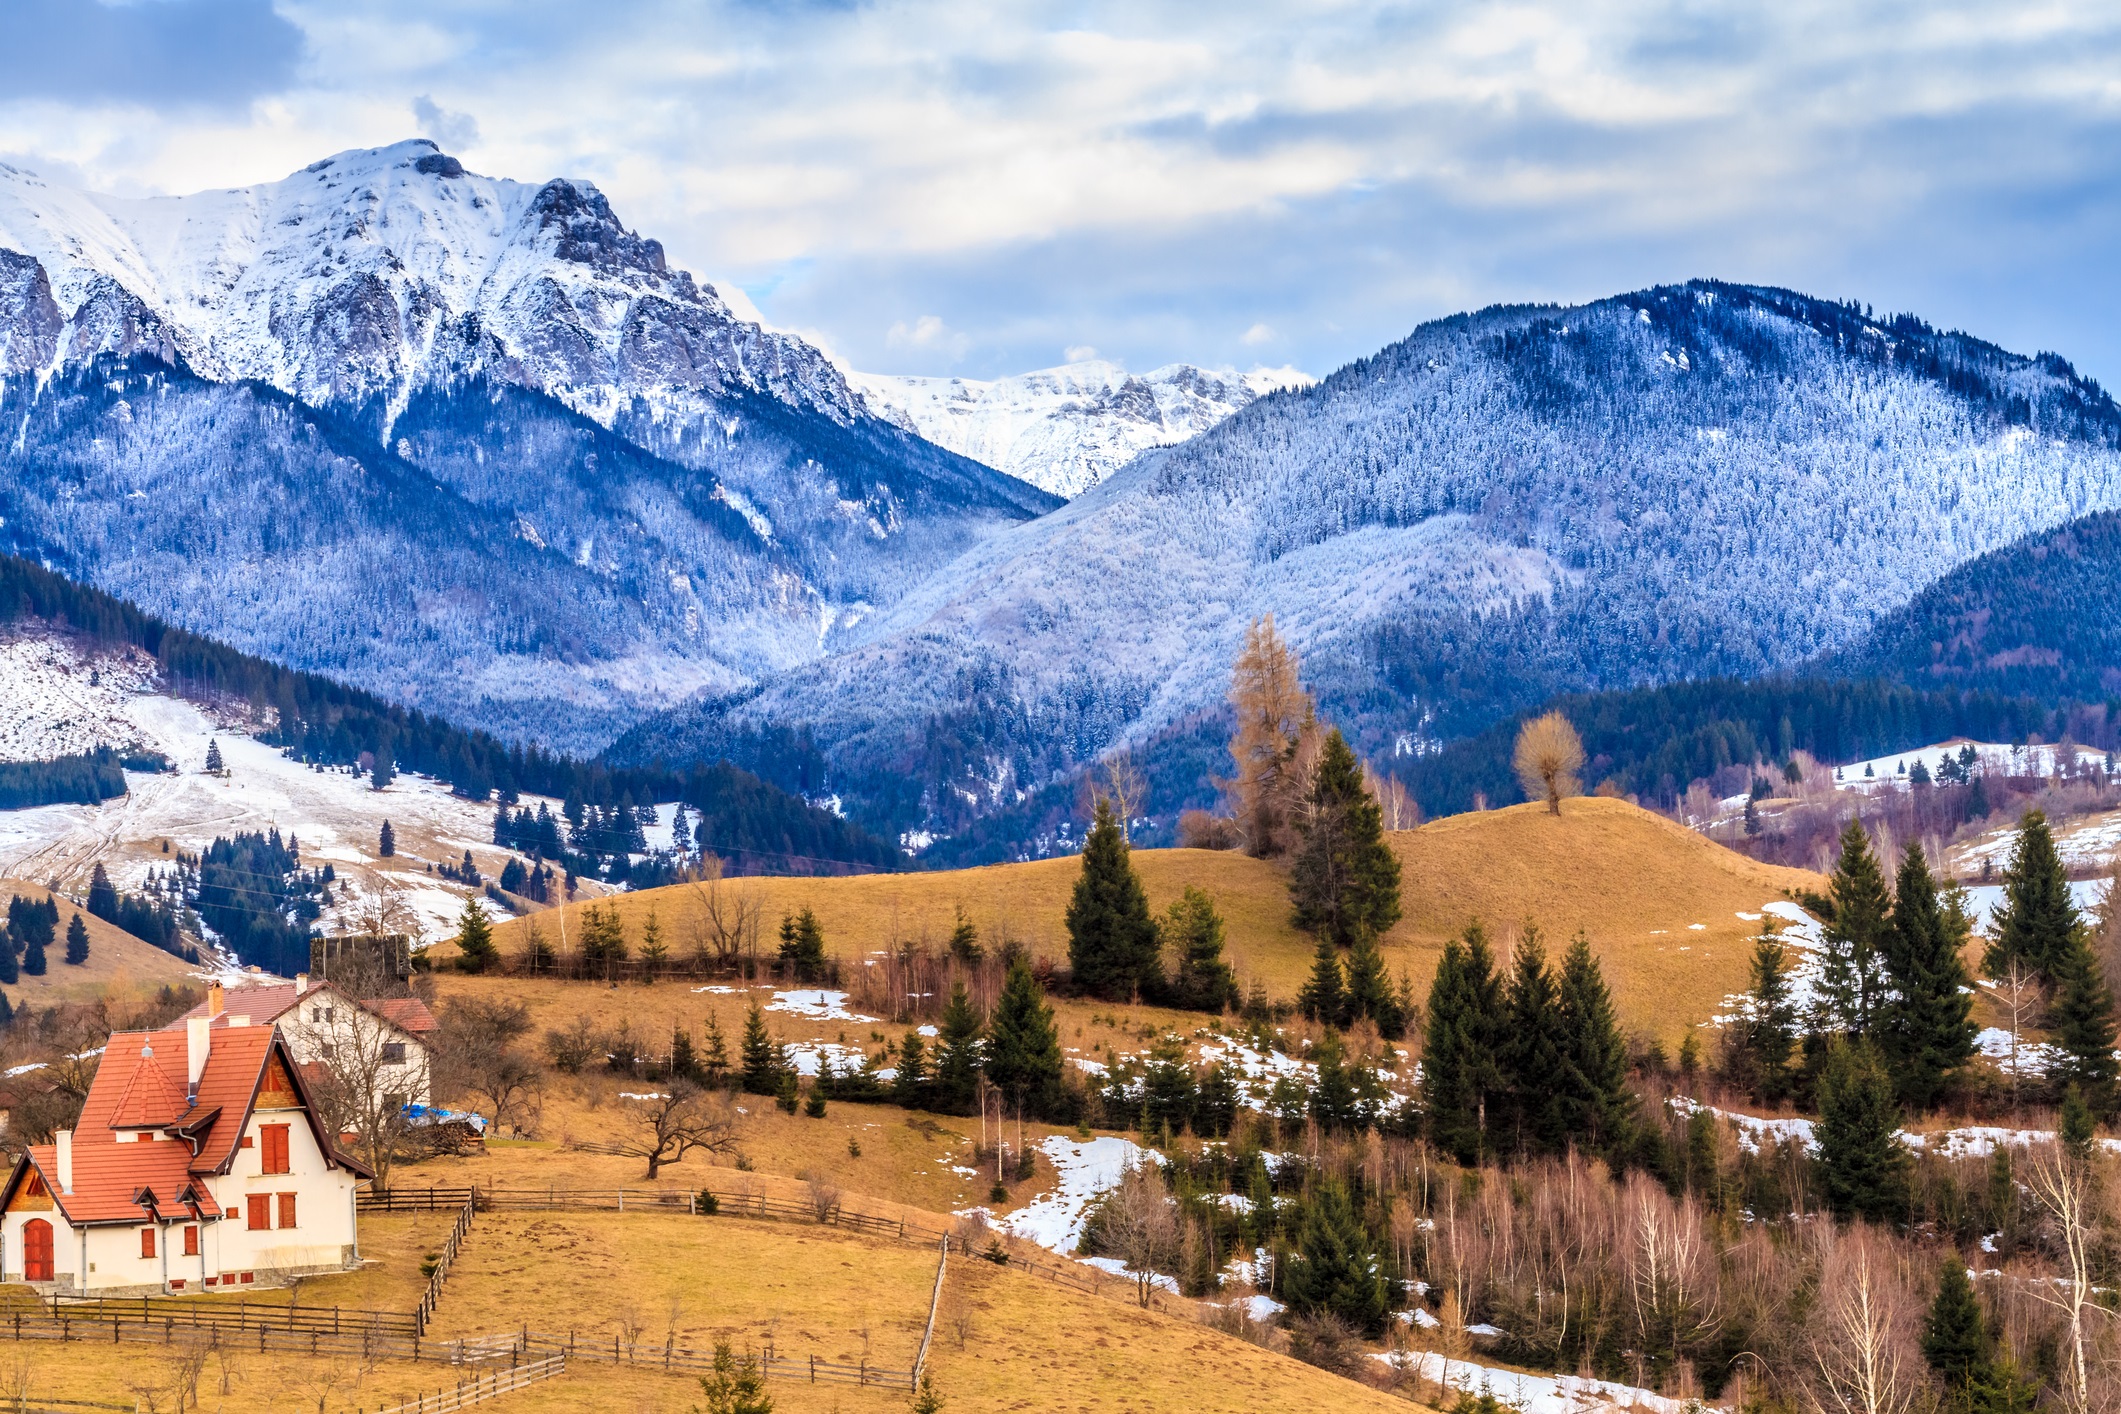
[0,0,2121,384]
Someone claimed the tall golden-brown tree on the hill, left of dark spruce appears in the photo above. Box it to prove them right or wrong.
[1228,615,1317,859]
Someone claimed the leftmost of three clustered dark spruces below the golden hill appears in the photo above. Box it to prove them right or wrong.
[1425,924,1508,1164]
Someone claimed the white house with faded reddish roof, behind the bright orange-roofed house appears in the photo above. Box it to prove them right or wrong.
[185,973,435,1109]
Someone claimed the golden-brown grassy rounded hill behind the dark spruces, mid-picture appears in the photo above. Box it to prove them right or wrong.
[485,797,1820,1039]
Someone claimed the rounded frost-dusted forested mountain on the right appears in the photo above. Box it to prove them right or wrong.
[621,282,2121,847]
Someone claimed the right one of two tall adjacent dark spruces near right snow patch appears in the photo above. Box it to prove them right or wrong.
[1879,844,1977,1111]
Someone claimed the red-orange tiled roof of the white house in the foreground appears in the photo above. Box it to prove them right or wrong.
[0,1026,367,1223]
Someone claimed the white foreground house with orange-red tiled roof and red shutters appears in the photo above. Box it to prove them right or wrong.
[0,1018,373,1295]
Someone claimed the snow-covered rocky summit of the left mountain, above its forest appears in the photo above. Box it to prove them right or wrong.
[0,138,859,424]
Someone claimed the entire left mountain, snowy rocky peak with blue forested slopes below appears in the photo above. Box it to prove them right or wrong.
[0,142,1056,750]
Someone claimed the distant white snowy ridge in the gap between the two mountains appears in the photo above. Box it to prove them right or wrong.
[848,358,1317,496]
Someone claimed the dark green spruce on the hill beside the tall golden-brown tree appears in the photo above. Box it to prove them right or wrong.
[1290,727,1400,948]
